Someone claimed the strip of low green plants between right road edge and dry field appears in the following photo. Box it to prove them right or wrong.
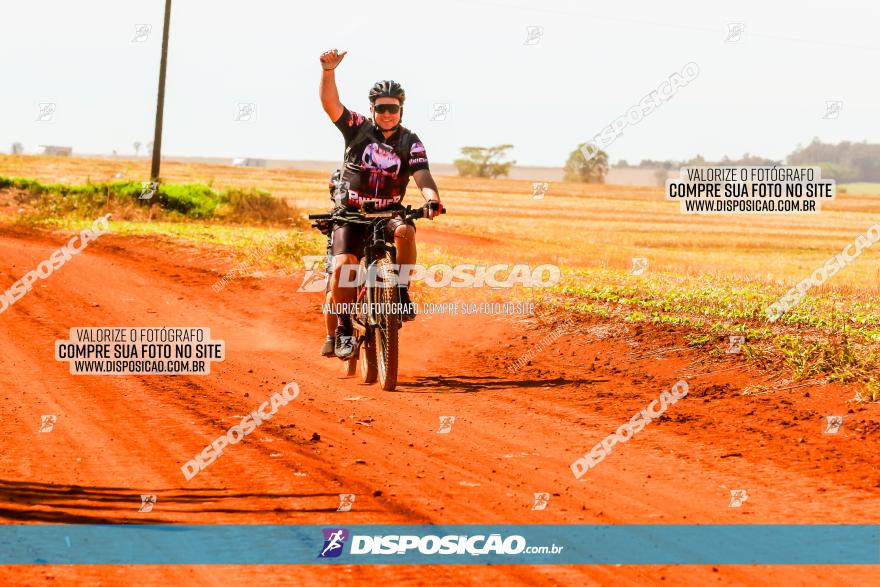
[544,268,880,401]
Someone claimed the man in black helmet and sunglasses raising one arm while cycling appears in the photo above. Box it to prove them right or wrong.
[320,49,443,359]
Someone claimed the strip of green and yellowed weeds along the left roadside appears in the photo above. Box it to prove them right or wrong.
[0,176,316,270]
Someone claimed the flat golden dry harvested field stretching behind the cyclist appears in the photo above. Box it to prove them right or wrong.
[6,156,880,278]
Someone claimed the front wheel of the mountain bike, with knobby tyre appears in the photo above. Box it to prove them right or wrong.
[373,255,400,391]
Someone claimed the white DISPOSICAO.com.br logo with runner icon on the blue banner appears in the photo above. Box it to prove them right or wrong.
[318,528,564,558]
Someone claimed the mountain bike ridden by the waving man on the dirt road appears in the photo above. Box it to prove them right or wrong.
[309,203,446,391]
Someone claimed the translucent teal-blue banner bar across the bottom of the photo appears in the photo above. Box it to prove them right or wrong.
[0,516,880,565]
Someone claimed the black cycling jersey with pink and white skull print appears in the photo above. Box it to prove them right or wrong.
[334,107,428,210]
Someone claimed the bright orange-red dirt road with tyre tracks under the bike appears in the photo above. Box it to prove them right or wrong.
[0,229,880,586]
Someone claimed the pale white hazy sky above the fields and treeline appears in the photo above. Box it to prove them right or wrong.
[0,0,880,166]
